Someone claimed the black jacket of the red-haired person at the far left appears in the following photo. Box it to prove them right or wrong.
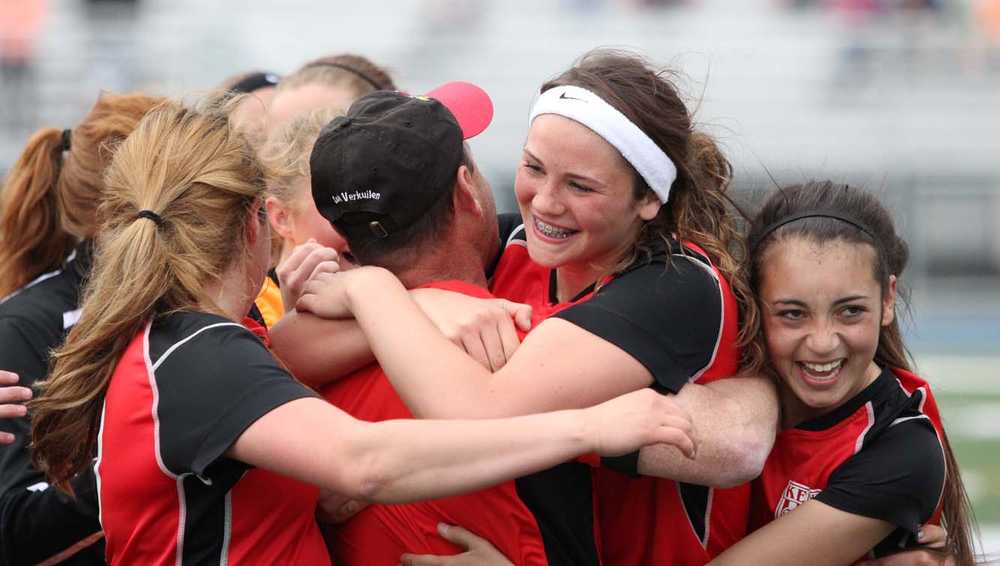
[0,243,104,565]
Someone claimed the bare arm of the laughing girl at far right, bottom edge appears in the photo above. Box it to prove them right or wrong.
[711,500,894,566]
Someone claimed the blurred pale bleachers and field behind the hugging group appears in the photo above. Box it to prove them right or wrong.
[0,0,1000,555]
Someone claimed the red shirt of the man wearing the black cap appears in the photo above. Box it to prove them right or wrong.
[322,281,548,566]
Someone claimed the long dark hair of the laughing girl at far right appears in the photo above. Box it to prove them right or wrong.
[747,181,975,564]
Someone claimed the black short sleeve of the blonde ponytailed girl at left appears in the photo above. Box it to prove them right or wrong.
[155,325,315,476]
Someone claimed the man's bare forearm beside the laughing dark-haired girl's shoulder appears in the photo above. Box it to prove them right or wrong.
[639,377,779,487]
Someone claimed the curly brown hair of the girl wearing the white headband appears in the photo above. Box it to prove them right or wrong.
[541,49,757,350]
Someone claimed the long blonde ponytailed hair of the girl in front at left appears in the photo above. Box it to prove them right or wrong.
[32,97,264,489]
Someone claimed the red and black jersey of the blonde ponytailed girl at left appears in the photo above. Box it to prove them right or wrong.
[96,312,329,565]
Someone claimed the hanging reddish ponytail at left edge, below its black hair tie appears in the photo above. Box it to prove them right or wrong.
[0,128,75,298]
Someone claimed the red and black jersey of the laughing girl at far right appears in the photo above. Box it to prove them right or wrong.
[752,369,946,560]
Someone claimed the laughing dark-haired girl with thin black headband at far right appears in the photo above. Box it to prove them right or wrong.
[716,182,974,566]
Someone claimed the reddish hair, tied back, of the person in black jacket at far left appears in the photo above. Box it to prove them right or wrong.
[0,94,163,297]
